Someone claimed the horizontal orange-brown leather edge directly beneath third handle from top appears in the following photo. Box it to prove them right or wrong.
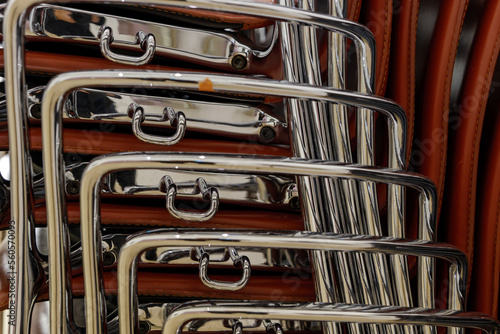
[24,202,304,231]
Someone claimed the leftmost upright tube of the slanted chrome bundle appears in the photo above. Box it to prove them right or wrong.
[279,0,342,334]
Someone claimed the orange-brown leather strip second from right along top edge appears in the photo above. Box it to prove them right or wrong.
[413,0,469,216]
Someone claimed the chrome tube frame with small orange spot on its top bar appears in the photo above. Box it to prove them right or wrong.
[40,71,406,332]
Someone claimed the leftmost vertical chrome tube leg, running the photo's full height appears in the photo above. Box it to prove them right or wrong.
[3,1,43,334]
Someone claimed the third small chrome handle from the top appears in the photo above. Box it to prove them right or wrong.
[160,175,219,222]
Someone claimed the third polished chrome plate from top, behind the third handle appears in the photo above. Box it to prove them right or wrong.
[23,155,298,207]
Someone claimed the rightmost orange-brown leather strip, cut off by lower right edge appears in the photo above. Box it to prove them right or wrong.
[468,101,500,317]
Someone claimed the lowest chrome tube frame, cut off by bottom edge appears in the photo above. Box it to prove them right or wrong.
[163,302,500,334]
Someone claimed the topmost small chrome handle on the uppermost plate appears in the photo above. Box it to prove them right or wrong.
[99,26,156,66]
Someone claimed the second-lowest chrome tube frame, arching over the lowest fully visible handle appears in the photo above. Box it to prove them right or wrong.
[115,230,467,334]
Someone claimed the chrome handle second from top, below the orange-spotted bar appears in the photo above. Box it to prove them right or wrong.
[128,103,186,145]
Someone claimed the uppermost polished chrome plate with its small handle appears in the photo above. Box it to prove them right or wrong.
[29,5,266,70]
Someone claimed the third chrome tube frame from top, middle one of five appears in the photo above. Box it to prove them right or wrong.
[76,153,437,334]
